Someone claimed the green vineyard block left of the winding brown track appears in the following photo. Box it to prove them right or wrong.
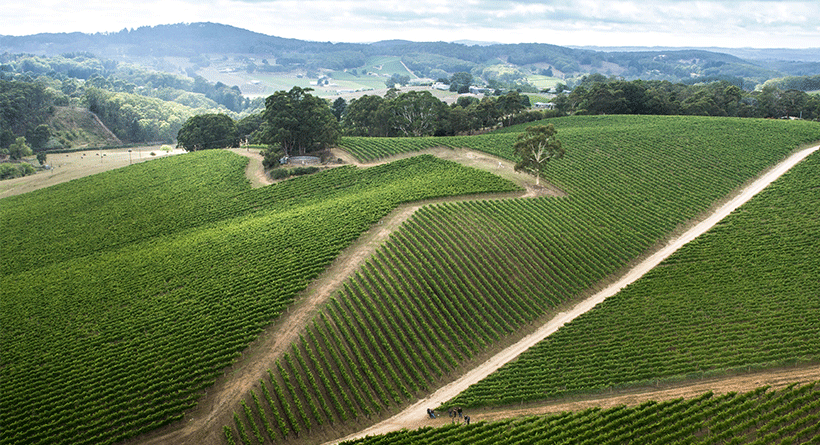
[0,150,517,444]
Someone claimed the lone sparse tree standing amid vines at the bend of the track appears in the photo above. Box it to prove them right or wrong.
[513,124,564,185]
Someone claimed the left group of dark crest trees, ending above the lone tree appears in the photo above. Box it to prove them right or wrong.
[177,87,560,169]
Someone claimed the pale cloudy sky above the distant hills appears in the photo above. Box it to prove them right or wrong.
[0,0,820,51]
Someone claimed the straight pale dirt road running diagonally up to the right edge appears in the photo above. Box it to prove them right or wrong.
[331,146,820,443]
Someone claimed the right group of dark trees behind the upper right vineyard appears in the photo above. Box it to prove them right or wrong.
[554,74,820,119]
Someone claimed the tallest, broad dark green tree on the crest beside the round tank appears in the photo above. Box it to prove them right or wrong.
[264,87,340,156]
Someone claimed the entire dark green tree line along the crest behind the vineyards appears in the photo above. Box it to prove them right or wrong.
[178,73,820,168]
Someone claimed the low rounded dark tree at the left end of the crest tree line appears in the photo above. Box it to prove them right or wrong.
[177,113,239,151]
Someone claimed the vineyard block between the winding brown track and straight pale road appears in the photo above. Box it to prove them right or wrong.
[227,116,820,441]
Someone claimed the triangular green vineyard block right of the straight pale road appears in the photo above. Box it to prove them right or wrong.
[449,148,820,406]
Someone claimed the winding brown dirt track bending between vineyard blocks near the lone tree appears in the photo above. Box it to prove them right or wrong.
[138,148,563,445]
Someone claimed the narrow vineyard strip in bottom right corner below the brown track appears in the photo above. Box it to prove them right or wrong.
[336,383,820,445]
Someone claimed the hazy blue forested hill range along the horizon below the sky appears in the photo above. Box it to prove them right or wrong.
[0,23,820,84]
